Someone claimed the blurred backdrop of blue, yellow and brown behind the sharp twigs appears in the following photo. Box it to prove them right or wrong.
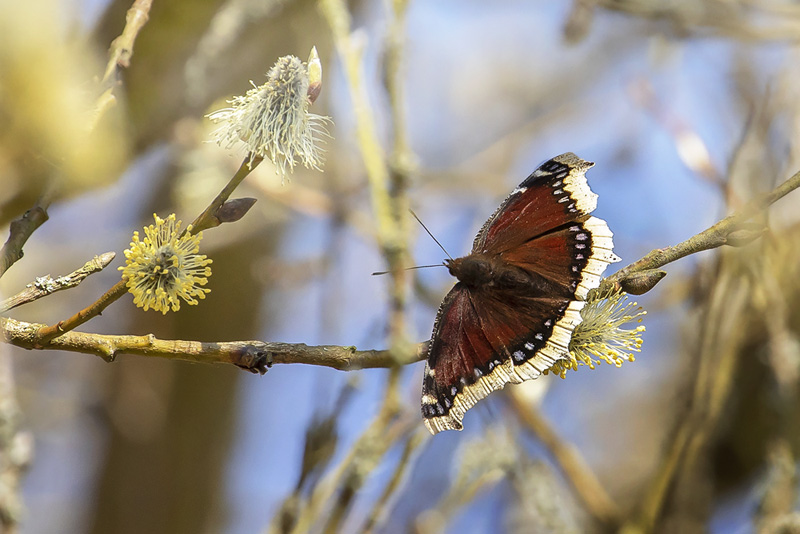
[0,0,800,534]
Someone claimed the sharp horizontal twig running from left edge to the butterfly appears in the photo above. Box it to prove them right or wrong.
[0,318,427,374]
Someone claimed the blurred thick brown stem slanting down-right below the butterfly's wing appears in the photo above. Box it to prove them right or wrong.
[506,389,622,526]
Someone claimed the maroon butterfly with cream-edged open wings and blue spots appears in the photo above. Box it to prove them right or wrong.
[422,153,619,434]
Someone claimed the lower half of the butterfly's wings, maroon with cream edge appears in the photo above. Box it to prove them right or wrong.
[422,283,583,434]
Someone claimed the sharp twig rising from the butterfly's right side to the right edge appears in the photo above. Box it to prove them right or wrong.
[593,171,800,295]
